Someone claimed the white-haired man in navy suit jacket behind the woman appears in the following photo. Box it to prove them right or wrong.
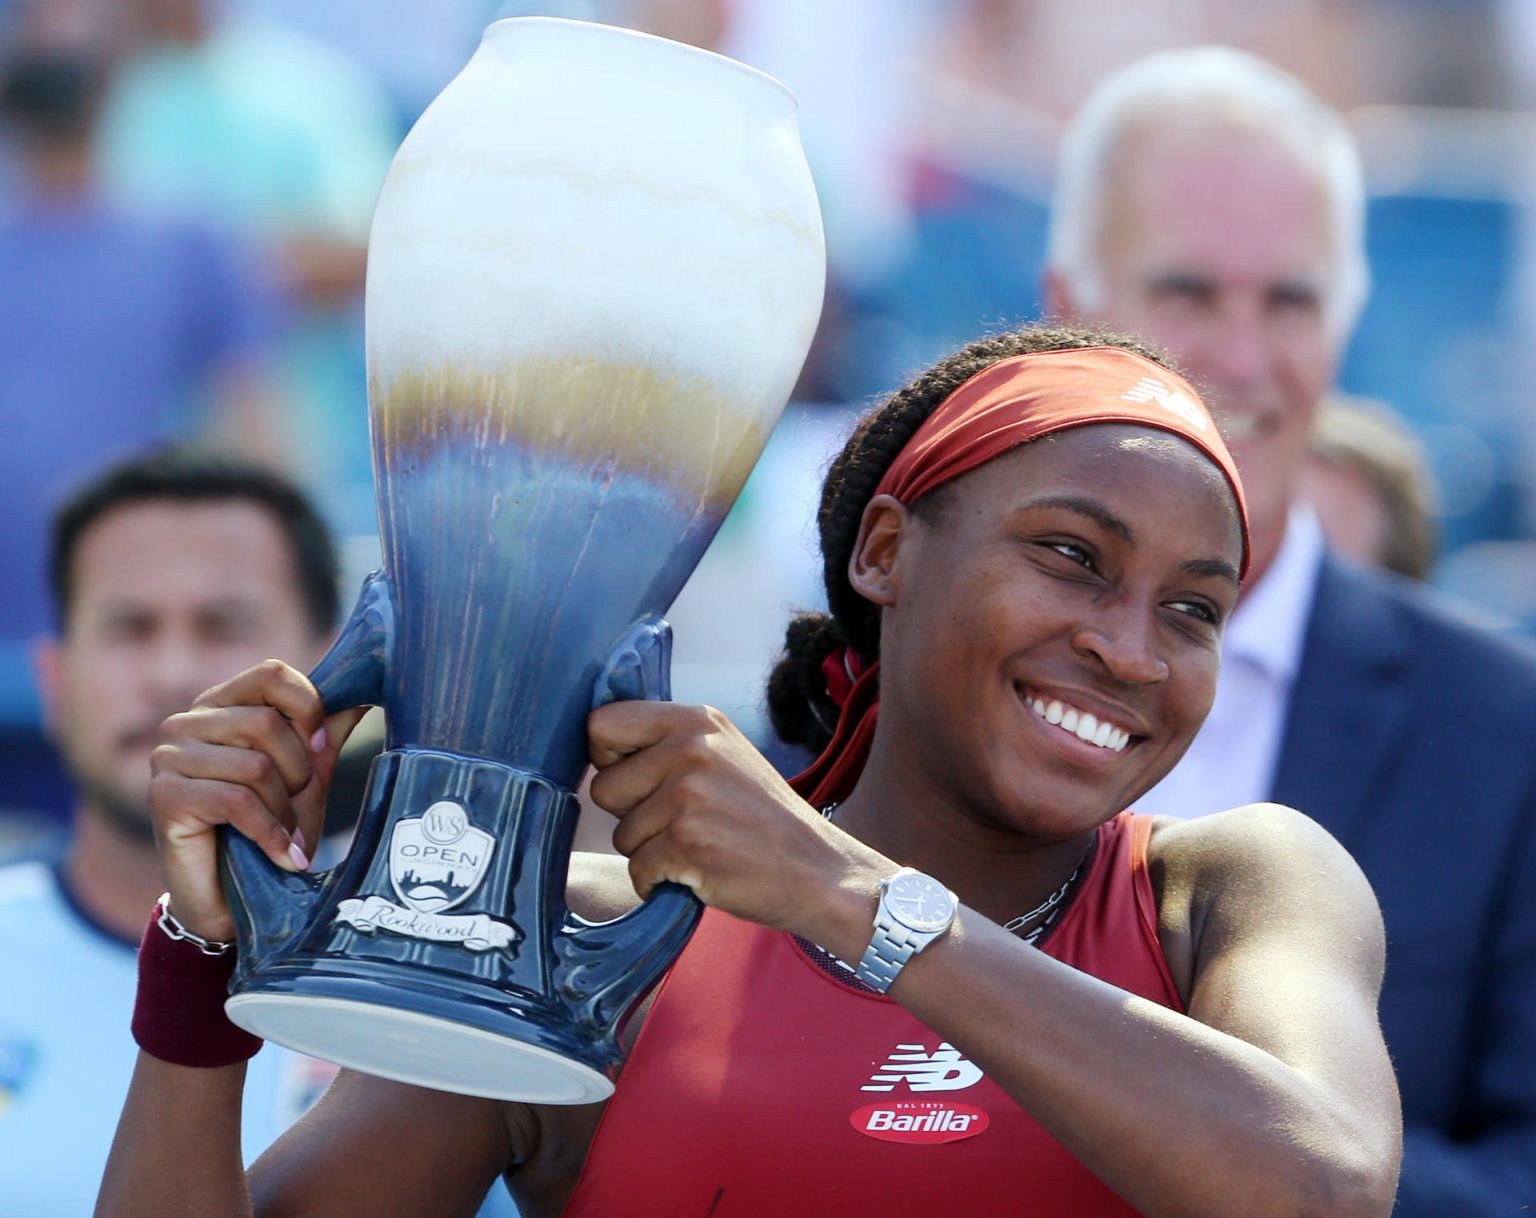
[1046,48,1536,1218]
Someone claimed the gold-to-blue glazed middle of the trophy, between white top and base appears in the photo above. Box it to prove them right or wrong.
[375,355,771,786]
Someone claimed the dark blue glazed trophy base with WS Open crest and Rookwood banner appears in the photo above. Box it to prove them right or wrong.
[226,750,632,1103]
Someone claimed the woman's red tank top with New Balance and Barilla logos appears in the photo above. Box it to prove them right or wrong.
[562,813,1181,1218]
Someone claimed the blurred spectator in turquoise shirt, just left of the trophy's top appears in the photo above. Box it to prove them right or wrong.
[97,0,399,531]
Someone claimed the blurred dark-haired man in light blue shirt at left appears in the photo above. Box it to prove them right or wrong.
[0,448,511,1218]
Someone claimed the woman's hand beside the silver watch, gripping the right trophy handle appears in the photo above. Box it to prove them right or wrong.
[587,702,895,937]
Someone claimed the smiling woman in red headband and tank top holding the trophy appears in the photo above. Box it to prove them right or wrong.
[98,329,1401,1218]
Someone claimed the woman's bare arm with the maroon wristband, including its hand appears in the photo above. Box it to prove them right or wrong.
[97,662,533,1218]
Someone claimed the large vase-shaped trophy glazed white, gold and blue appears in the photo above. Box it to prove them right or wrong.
[213,18,825,1103]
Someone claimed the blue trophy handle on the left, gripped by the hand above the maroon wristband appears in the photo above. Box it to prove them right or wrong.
[218,571,395,969]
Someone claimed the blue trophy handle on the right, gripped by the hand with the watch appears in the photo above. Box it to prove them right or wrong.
[556,617,703,1032]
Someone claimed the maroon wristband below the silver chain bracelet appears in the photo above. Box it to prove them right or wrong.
[134,903,263,1067]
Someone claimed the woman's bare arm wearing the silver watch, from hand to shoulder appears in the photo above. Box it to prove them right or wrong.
[593,703,1401,1218]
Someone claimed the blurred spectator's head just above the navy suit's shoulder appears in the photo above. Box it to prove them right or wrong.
[1301,393,1436,582]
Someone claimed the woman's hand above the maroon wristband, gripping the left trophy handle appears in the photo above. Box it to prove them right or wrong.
[149,660,366,938]
